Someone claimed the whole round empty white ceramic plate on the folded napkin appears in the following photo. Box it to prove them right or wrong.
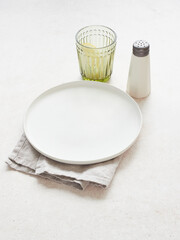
[24,81,142,164]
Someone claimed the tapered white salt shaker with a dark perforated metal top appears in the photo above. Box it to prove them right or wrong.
[127,40,151,98]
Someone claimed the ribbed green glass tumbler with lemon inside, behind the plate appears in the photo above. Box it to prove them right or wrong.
[76,25,117,82]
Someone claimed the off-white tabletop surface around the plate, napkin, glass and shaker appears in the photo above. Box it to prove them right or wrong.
[0,0,180,240]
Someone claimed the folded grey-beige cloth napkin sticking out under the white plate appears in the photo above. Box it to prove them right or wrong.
[6,134,121,190]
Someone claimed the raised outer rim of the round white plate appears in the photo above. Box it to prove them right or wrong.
[23,80,143,165]
